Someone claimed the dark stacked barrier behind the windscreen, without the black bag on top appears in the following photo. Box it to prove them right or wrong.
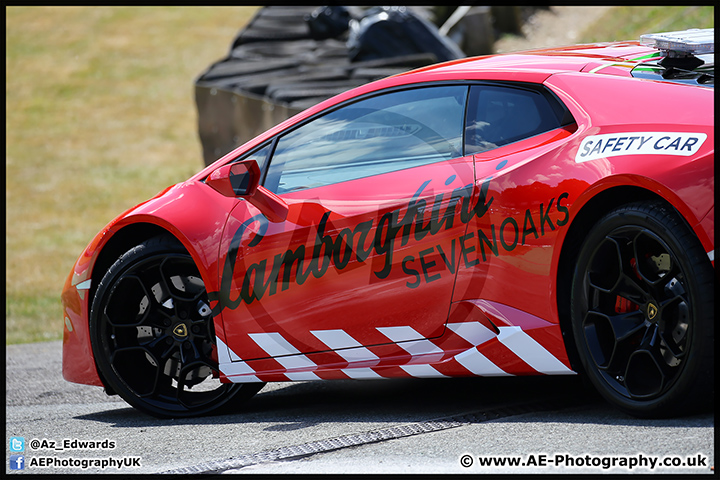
[195,6,464,165]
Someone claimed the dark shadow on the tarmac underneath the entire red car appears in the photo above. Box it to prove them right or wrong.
[75,376,714,432]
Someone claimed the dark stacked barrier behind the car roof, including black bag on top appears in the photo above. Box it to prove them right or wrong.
[195,6,544,165]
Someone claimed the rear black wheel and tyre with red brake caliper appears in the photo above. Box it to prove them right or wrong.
[571,202,715,417]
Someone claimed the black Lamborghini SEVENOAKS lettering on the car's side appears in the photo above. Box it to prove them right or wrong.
[208,177,569,315]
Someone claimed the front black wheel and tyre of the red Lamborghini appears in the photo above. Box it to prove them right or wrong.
[90,236,264,418]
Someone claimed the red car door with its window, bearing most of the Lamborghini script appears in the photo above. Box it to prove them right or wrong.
[221,85,474,366]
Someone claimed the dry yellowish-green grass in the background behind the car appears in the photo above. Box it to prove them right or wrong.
[5,7,714,343]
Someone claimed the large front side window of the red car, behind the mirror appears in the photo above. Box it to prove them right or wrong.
[265,86,468,194]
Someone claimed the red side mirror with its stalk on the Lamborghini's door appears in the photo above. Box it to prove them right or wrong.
[205,160,288,223]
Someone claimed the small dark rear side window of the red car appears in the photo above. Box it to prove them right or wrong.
[465,85,564,155]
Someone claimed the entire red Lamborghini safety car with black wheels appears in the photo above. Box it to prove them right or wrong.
[62,30,715,417]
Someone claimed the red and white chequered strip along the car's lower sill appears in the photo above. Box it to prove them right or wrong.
[217,322,575,383]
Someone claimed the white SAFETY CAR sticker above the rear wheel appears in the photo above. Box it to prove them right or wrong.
[575,132,707,163]
